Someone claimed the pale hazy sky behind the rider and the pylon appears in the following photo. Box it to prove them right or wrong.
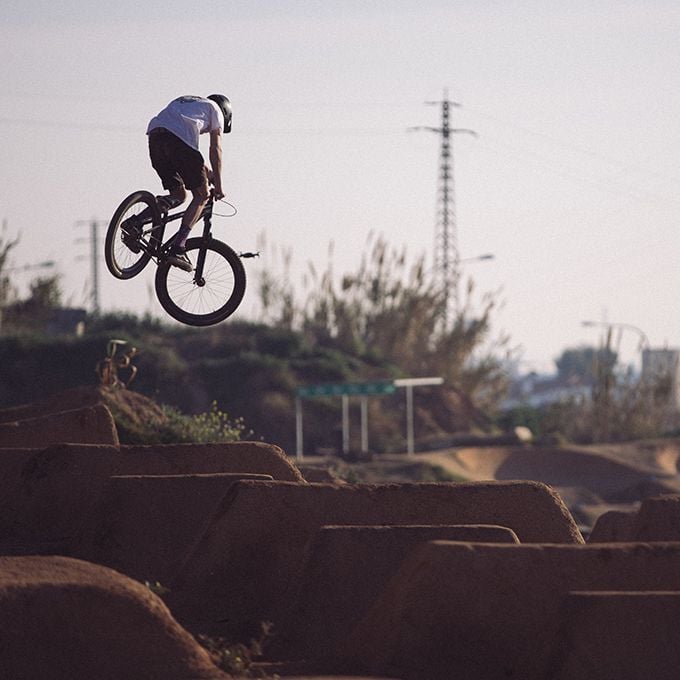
[0,0,680,369]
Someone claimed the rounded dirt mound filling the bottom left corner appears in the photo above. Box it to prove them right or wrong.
[0,557,229,680]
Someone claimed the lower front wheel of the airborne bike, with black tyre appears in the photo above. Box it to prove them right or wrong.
[155,238,246,326]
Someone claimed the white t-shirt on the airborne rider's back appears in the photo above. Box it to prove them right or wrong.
[146,97,224,151]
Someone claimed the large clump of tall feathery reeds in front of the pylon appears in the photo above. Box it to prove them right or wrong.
[258,236,507,431]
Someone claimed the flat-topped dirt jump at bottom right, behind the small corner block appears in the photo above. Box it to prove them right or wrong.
[342,541,680,680]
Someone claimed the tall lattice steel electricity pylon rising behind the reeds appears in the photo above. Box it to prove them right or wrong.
[409,90,477,329]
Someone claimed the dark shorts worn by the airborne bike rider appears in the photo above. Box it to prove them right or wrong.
[149,128,208,191]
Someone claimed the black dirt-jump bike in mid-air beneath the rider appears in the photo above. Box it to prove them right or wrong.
[105,191,250,326]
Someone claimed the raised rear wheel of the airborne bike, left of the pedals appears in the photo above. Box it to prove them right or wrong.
[104,191,160,279]
